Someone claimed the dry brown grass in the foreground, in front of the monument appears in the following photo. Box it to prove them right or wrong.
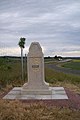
[0,100,80,120]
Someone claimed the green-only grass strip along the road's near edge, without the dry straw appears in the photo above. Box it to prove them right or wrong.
[45,68,80,87]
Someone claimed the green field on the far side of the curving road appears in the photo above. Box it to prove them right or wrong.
[62,60,80,70]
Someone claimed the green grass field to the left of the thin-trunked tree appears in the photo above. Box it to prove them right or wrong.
[0,58,27,86]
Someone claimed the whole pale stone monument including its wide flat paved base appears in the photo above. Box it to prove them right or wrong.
[3,42,68,100]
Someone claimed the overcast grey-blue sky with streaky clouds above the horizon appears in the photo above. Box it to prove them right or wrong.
[0,0,80,57]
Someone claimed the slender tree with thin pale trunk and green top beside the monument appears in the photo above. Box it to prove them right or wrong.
[18,37,26,80]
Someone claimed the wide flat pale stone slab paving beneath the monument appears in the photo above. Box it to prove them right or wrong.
[3,87,68,100]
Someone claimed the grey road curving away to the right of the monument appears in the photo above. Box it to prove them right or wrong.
[45,64,80,76]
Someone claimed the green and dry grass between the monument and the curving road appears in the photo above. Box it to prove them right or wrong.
[45,68,80,94]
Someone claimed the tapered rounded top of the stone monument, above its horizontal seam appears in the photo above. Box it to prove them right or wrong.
[28,42,43,57]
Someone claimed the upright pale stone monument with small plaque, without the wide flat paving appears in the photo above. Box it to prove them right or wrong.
[21,42,51,94]
